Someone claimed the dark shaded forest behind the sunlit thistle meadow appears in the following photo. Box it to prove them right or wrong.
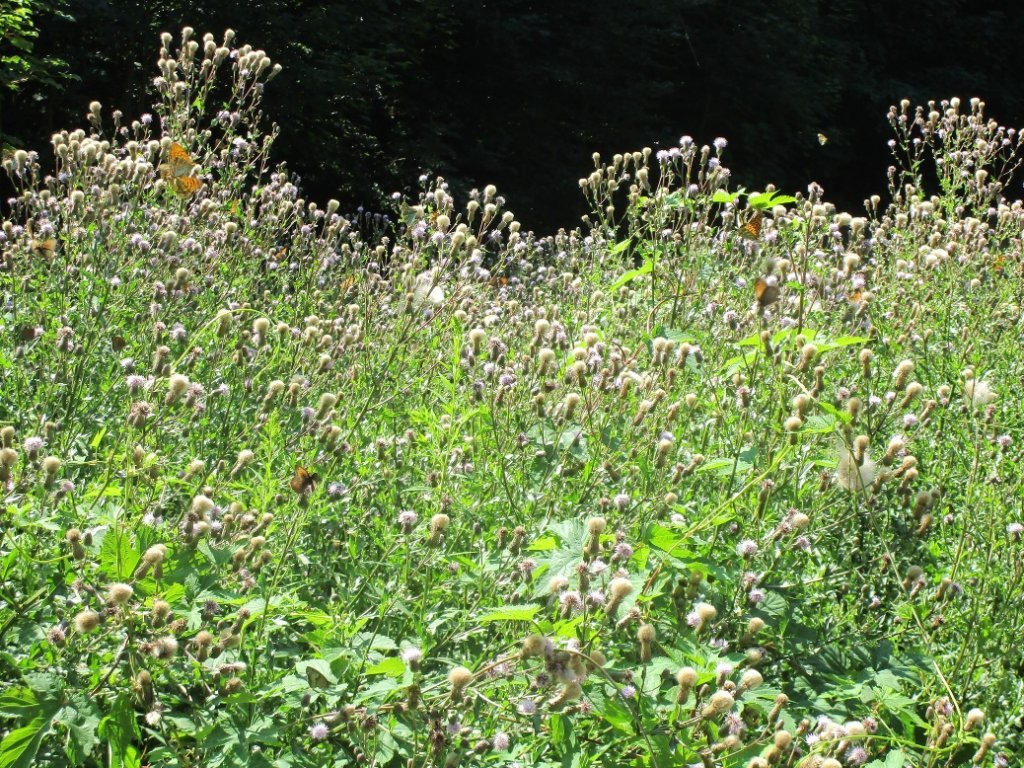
[0,0,1024,231]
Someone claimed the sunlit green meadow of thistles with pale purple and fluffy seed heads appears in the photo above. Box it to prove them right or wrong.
[0,30,1024,768]
